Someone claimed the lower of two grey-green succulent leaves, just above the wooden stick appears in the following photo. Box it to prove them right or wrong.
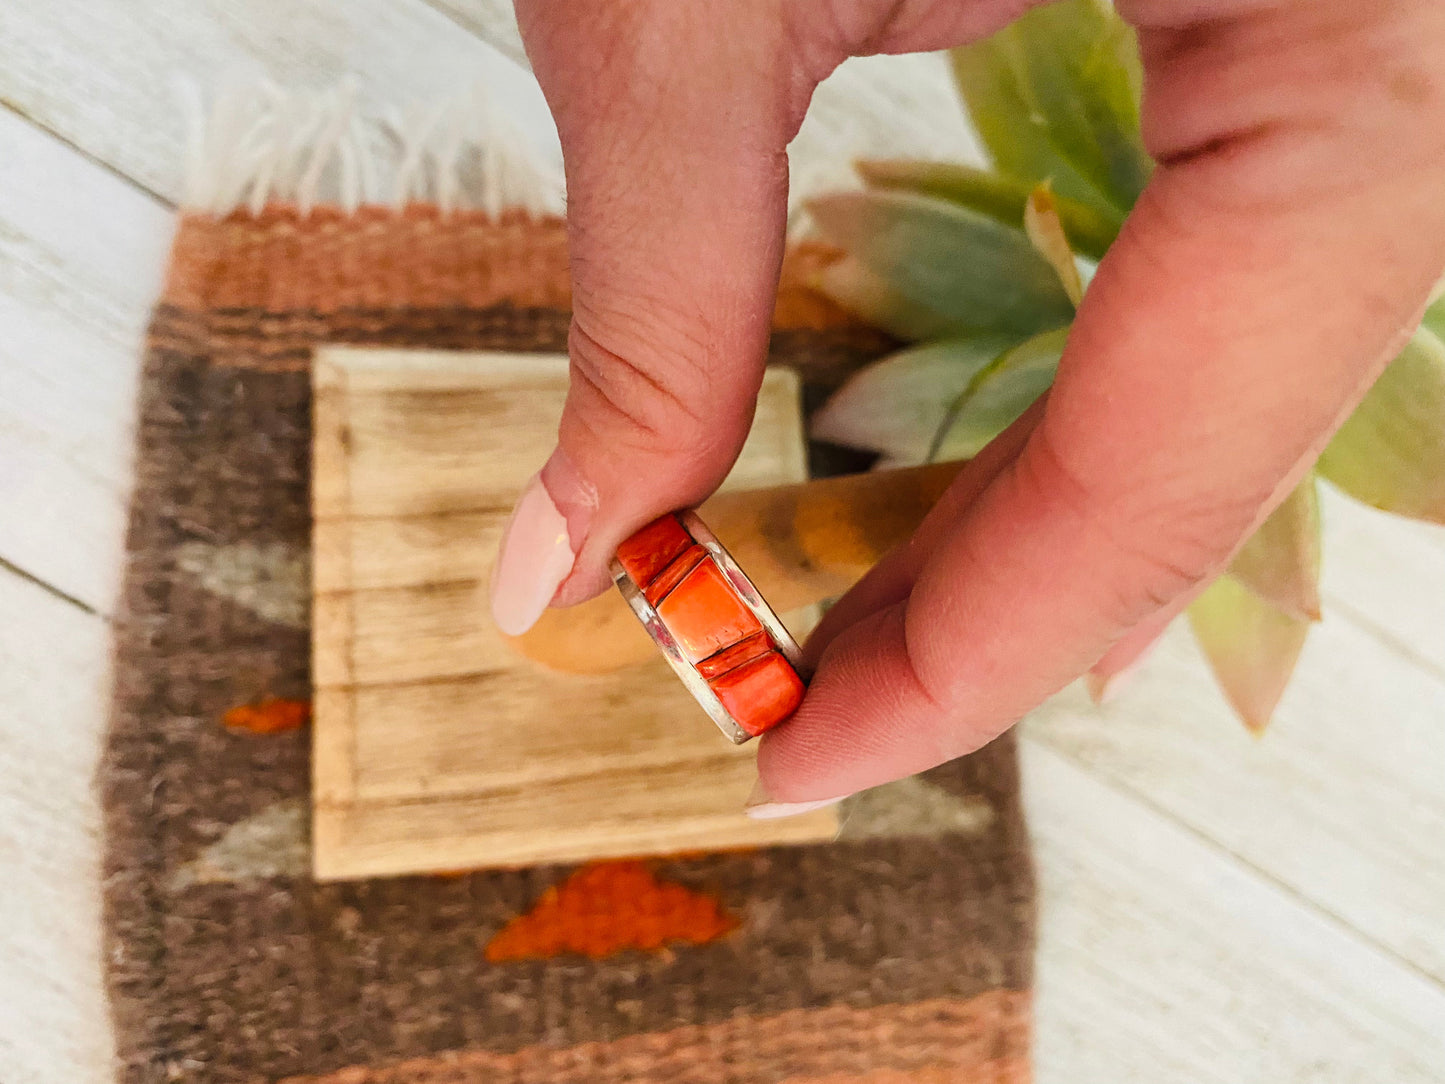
[811,332,1014,467]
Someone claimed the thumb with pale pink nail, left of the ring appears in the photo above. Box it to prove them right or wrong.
[493,0,811,635]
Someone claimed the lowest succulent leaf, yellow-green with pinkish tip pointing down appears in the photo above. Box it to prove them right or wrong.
[1189,574,1309,733]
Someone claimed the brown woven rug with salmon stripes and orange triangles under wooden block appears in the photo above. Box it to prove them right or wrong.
[101,205,1033,1084]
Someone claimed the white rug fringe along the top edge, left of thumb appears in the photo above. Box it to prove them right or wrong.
[176,79,565,215]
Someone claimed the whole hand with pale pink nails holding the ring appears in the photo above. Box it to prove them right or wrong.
[494,0,1445,812]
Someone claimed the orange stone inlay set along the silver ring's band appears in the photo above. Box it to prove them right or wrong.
[617,515,803,736]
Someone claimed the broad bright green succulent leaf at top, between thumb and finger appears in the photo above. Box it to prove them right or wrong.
[952,0,1153,212]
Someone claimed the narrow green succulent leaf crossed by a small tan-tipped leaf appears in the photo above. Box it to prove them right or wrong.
[857,159,1124,260]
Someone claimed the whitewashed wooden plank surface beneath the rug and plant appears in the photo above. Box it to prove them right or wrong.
[0,0,1445,1084]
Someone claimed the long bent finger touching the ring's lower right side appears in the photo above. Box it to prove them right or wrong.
[759,4,1445,804]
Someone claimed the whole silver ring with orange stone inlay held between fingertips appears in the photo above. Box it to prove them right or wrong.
[611,510,805,744]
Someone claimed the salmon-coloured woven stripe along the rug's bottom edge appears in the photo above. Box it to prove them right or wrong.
[282,990,1029,1084]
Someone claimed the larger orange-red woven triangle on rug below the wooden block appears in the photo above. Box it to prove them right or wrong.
[486,861,738,964]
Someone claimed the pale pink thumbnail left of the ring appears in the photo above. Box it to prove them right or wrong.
[491,474,577,636]
